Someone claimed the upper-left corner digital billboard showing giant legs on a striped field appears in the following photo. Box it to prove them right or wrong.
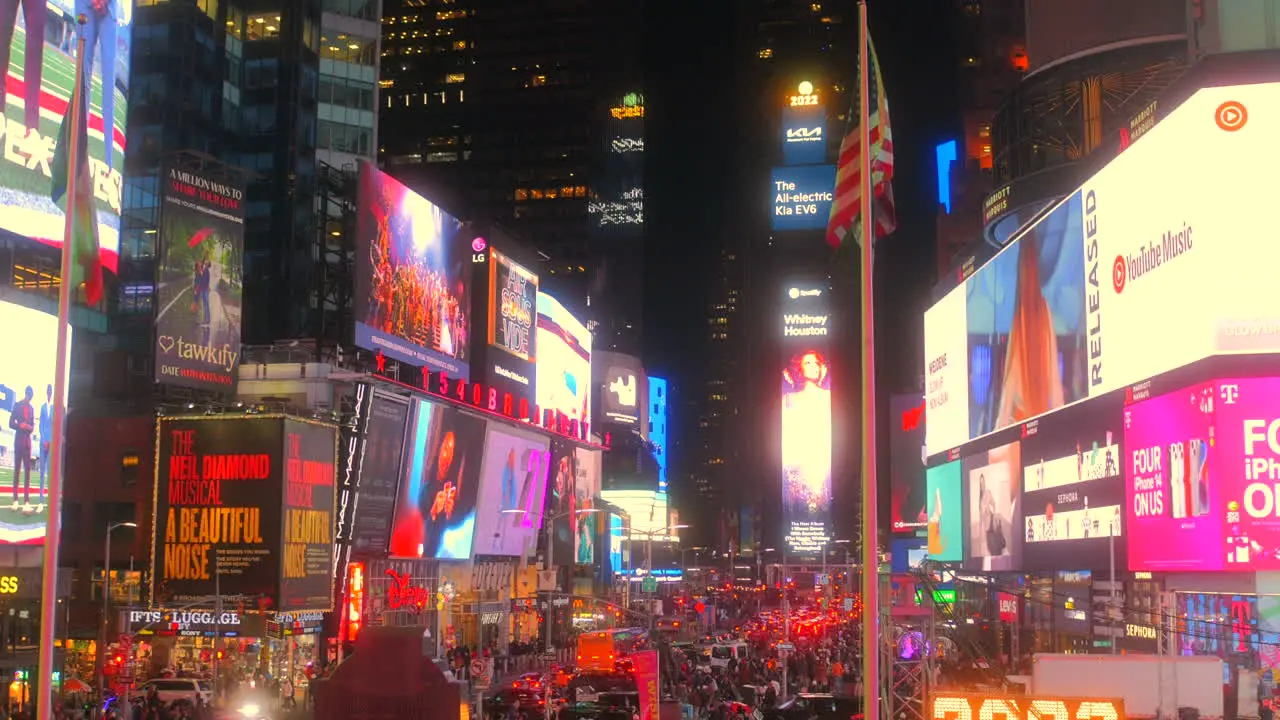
[0,0,133,272]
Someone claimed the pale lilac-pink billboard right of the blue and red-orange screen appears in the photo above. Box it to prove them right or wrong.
[475,423,550,557]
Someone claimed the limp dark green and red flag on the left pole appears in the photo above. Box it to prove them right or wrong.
[50,52,103,305]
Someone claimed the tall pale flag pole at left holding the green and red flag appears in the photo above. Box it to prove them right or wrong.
[37,15,87,720]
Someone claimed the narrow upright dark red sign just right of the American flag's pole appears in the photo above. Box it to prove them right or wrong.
[888,395,929,534]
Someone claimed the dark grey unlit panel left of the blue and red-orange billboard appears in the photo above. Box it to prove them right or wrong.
[352,392,410,555]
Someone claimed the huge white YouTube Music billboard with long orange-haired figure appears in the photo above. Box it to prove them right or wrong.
[924,83,1280,456]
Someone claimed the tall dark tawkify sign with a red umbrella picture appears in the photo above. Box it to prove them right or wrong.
[155,168,244,393]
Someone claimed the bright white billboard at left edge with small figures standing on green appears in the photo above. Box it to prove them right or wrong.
[0,302,72,544]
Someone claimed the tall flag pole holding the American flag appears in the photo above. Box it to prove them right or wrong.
[858,0,881,720]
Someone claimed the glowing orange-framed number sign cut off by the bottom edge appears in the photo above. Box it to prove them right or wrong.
[929,692,1125,720]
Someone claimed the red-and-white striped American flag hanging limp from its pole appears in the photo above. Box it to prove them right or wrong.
[827,36,897,247]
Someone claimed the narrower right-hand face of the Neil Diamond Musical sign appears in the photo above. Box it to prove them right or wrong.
[276,419,338,610]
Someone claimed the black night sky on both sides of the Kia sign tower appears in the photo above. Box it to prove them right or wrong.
[644,0,959,397]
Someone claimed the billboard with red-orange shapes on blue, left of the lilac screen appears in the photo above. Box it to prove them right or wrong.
[390,400,485,560]
